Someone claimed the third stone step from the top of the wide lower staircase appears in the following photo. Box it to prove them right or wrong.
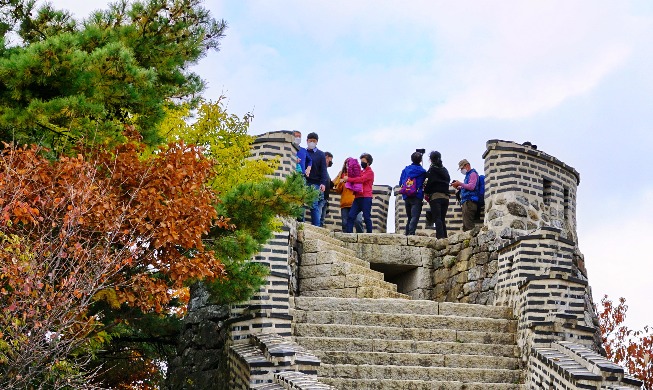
[293,323,515,349]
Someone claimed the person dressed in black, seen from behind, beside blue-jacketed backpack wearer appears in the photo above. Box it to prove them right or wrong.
[424,151,451,238]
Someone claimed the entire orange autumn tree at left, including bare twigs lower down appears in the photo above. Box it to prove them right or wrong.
[0,143,232,388]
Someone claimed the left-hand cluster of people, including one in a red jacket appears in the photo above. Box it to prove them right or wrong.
[294,131,374,233]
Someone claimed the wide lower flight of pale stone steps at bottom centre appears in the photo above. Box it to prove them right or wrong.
[293,296,526,390]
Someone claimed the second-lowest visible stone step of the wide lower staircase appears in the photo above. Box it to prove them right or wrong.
[317,363,523,384]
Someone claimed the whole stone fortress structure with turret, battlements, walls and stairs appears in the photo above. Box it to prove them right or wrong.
[164,138,641,390]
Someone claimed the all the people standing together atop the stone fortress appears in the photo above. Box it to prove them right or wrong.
[294,131,482,238]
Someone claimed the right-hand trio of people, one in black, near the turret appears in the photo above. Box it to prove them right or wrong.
[399,149,481,238]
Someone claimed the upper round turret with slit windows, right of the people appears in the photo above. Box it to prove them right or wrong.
[483,140,580,242]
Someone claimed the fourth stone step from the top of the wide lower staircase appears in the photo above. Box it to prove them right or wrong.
[294,331,519,357]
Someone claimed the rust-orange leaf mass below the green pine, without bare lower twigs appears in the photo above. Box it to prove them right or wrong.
[0,143,228,312]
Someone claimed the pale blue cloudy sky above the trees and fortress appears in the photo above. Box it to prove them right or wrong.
[57,0,653,328]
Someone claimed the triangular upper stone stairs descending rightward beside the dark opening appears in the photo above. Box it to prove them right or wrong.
[299,224,410,299]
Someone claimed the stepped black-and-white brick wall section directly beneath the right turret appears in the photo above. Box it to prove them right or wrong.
[495,228,601,359]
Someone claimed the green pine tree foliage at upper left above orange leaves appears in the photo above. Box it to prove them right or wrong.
[0,0,226,151]
